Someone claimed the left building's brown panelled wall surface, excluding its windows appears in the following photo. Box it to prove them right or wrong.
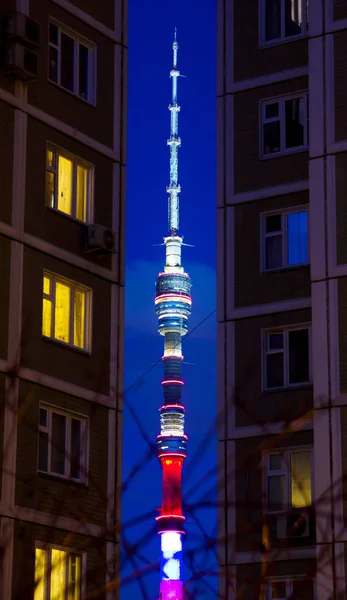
[0,0,127,600]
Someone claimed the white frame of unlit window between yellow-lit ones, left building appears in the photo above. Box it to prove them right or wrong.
[37,402,89,486]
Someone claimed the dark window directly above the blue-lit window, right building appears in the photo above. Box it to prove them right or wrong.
[261,94,307,158]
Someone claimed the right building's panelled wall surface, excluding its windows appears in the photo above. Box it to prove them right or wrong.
[217,0,347,600]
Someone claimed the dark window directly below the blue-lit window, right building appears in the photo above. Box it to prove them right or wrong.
[264,327,310,390]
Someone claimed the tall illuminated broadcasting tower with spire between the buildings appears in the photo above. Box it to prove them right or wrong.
[155,30,192,600]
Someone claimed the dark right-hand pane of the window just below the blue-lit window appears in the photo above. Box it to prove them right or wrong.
[288,329,310,383]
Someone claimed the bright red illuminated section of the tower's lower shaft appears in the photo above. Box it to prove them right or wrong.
[161,455,184,516]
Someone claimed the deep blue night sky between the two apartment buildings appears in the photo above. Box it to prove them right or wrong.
[122,0,216,600]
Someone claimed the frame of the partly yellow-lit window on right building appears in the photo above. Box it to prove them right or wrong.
[262,444,314,515]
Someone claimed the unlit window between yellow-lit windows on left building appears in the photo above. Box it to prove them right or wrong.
[38,405,87,483]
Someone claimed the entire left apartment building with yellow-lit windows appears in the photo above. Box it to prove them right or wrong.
[0,0,127,600]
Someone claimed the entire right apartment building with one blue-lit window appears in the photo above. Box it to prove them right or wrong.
[217,0,347,600]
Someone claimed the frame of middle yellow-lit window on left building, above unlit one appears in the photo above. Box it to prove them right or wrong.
[41,269,93,355]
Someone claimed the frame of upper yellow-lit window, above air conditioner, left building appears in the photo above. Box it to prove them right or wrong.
[45,142,95,225]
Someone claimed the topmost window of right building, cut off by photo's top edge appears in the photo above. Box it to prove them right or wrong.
[262,0,308,43]
